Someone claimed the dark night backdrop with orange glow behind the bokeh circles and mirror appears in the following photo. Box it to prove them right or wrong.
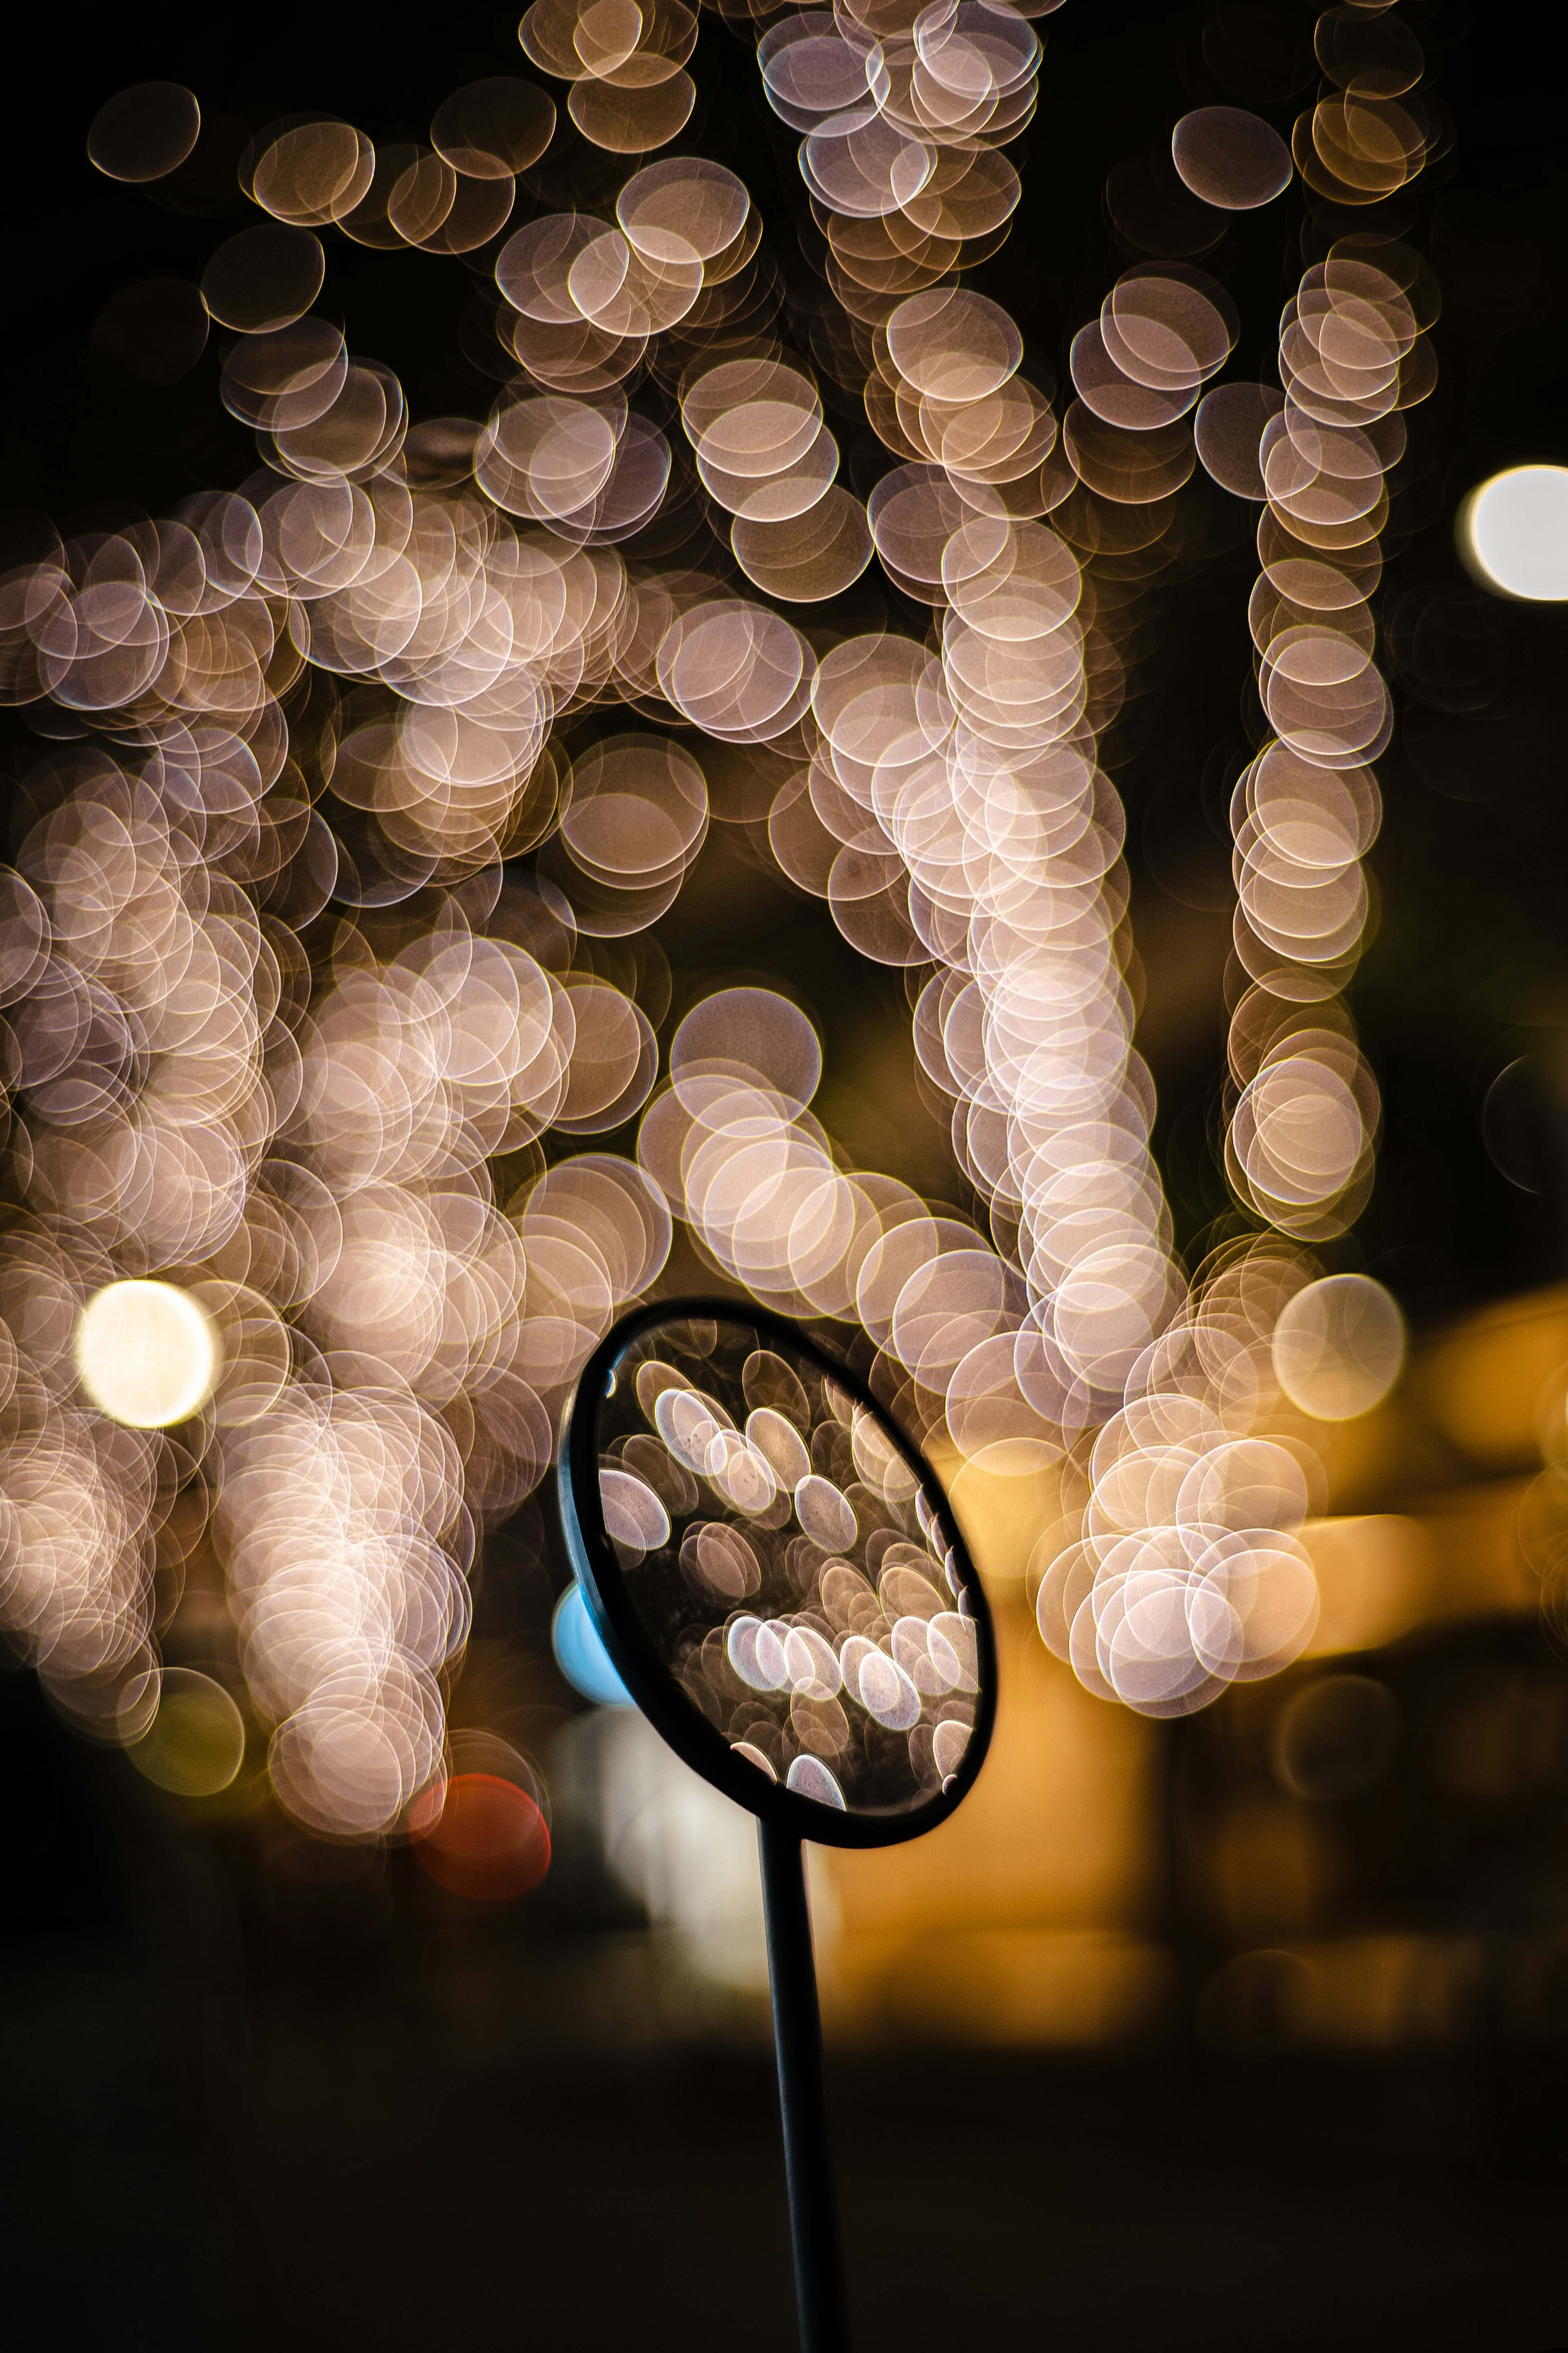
[0,0,1568,2348]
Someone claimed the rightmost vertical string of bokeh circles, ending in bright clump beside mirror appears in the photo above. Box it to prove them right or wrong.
[1039,7,1443,1715]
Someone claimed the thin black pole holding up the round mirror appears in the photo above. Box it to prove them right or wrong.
[757,1821,849,2353]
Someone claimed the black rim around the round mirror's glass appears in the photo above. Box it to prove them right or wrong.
[557,1299,997,1847]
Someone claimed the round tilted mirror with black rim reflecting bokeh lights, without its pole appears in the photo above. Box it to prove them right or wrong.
[559,1301,997,1847]
